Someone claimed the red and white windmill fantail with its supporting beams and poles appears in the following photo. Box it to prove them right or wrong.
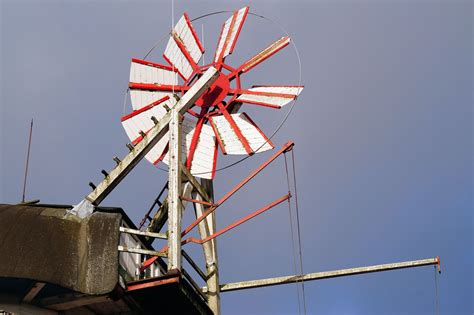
[67,7,439,314]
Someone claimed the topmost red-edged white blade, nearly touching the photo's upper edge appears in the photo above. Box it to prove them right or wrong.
[214,7,249,62]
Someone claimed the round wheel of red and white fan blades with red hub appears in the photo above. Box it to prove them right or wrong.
[122,7,303,179]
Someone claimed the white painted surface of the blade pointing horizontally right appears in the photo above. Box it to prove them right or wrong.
[237,86,303,107]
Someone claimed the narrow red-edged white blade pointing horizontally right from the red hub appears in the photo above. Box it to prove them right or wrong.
[236,85,303,108]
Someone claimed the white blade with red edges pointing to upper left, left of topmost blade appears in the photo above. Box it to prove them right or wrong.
[163,13,204,81]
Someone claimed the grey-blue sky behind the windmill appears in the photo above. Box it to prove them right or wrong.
[0,0,474,315]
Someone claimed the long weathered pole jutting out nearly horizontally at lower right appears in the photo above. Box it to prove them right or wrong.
[203,257,440,292]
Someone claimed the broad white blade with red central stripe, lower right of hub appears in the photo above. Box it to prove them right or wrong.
[209,113,274,155]
